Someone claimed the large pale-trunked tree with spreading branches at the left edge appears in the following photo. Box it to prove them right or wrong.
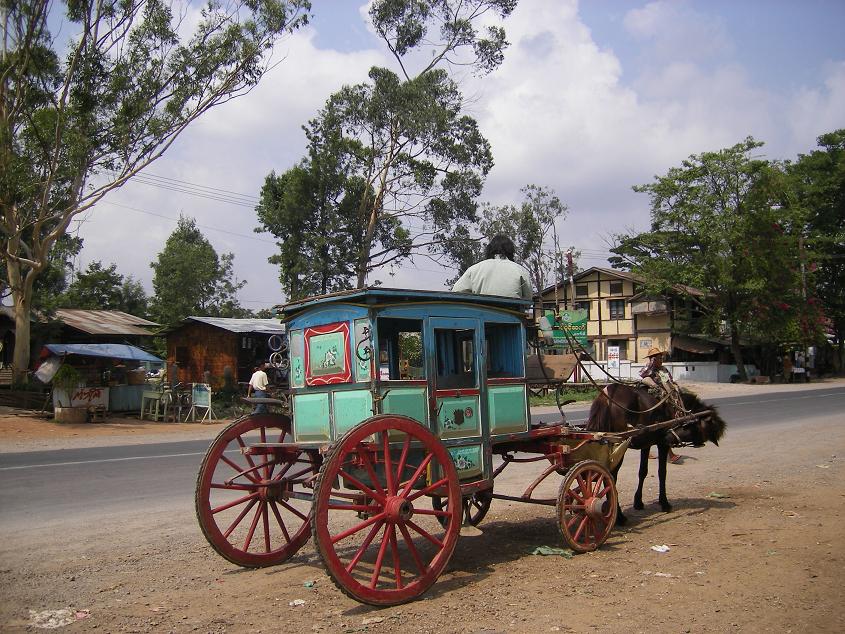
[0,0,310,376]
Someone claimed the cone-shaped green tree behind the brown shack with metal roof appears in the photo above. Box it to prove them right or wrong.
[150,216,248,326]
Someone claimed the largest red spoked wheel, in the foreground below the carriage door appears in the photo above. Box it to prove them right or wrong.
[311,415,462,605]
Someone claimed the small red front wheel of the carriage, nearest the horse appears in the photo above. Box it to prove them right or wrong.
[557,460,616,553]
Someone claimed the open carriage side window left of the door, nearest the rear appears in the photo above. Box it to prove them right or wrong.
[378,318,425,381]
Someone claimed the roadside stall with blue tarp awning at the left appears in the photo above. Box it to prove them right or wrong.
[36,343,164,412]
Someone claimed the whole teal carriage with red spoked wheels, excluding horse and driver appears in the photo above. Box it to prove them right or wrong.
[196,288,720,605]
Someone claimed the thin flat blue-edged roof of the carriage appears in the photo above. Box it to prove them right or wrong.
[276,286,531,321]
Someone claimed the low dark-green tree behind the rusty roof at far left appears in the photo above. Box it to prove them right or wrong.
[60,261,147,317]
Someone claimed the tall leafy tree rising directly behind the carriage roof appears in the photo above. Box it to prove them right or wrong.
[259,0,516,288]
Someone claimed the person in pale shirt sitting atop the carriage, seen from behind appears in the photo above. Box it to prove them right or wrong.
[452,234,534,300]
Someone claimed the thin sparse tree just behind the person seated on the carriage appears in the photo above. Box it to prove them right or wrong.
[480,185,568,291]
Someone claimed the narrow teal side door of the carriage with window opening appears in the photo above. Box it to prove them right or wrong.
[429,318,484,480]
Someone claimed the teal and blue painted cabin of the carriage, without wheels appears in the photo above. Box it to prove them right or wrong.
[284,289,529,482]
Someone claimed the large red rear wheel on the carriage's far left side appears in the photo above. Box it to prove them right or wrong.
[195,414,320,568]
